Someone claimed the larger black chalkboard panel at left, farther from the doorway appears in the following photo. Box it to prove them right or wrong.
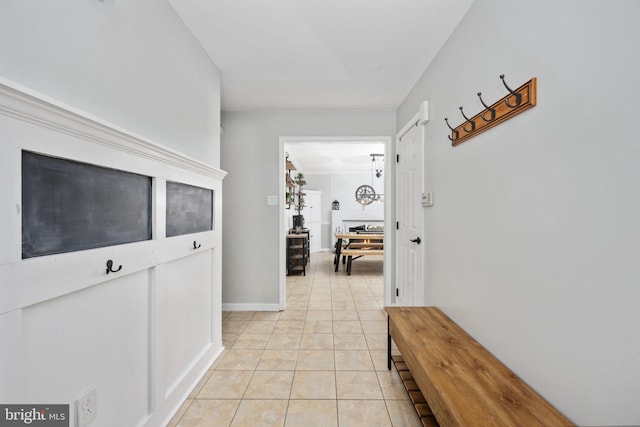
[22,151,151,258]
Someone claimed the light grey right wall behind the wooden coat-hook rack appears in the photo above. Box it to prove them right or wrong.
[397,0,640,425]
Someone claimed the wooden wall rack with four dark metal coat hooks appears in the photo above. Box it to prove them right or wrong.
[444,74,537,147]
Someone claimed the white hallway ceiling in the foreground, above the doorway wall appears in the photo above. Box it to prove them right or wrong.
[169,0,473,111]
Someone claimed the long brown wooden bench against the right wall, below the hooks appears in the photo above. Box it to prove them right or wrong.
[386,307,573,427]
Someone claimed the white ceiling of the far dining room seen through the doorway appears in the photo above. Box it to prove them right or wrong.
[284,141,384,175]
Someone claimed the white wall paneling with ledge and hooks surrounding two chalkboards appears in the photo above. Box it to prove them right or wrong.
[0,82,225,427]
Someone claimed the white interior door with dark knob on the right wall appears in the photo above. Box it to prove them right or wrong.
[395,123,425,306]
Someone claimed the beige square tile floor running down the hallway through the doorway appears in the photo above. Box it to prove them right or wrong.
[169,253,421,427]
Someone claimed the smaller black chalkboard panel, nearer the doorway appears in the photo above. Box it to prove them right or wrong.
[167,182,213,237]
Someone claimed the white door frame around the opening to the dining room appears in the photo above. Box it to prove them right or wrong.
[278,136,395,310]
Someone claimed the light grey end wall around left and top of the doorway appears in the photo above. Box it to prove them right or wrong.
[220,111,395,305]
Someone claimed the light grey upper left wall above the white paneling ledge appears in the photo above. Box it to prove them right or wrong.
[0,0,220,167]
